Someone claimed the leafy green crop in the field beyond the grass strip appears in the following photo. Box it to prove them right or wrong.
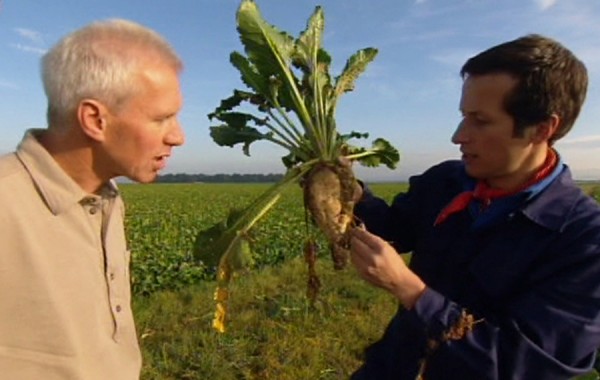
[120,183,405,295]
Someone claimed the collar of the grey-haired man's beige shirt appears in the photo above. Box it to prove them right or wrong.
[16,129,118,215]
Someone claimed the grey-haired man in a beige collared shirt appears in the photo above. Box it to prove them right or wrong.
[0,20,184,380]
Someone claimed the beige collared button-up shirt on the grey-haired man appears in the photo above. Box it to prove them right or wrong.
[0,131,141,380]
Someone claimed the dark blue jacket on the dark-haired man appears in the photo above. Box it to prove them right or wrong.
[352,161,600,380]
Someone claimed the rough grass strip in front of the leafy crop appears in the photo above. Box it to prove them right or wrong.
[134,252,397,380]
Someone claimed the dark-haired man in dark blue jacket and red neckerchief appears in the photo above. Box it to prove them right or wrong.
[351,35,600,380]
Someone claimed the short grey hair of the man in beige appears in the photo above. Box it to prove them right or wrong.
[41,19,183,126]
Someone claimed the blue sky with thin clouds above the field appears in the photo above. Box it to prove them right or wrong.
[0,0,600,180]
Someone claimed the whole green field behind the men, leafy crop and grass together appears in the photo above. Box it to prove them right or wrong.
[120,183,600,380]
